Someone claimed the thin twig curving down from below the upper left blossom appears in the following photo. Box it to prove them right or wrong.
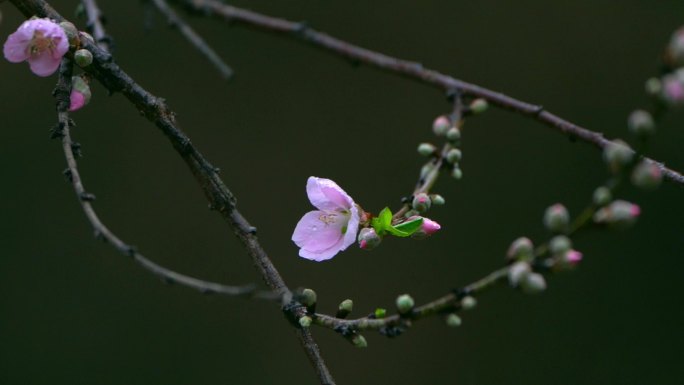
[53,58,264,299]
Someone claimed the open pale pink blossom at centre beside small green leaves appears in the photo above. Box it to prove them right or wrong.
[292,176,360,261]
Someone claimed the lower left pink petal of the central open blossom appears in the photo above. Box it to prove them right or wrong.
[292,211,348,253]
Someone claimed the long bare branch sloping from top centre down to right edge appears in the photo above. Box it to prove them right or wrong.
[183,0,684,185]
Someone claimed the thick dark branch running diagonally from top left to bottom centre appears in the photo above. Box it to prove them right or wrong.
[11,0,335,384]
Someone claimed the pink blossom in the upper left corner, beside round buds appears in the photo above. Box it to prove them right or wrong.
[3,19,69,76]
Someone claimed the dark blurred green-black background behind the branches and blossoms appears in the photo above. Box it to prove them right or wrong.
[0,0,684,384]
